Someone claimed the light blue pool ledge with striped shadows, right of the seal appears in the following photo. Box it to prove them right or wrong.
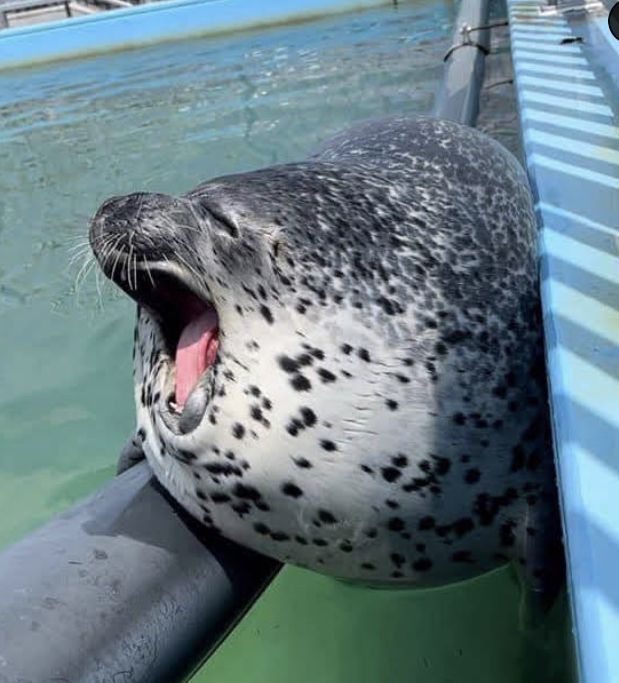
[508,0,619,683]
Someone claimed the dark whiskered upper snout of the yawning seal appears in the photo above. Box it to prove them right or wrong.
[89,192,196,274]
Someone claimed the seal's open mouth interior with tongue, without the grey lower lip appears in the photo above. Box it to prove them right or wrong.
[114,265,219,417]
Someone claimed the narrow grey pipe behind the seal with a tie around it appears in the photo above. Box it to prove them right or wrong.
[434,0,490,126]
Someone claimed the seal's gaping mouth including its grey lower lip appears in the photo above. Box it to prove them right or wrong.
[117,264,219,434]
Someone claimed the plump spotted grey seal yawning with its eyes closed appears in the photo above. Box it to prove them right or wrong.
[90,117,562,591]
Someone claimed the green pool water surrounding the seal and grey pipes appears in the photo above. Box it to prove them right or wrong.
[0,1,567,683]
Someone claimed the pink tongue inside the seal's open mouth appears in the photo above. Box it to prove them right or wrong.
[176,309,219,408]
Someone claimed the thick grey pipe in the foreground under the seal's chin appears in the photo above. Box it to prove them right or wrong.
[0,464,279,683]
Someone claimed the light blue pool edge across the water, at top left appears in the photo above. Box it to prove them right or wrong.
[0,0,395,71]
